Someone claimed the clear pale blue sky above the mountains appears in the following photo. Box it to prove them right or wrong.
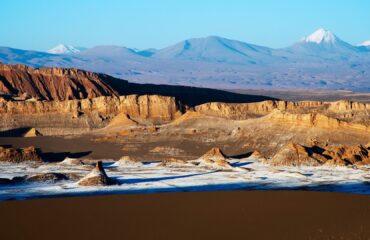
[0,0,370,50]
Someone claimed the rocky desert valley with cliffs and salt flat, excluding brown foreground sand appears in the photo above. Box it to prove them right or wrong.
[0,64,370,200]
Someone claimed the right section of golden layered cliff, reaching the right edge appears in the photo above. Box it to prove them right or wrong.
[195,101,370,131]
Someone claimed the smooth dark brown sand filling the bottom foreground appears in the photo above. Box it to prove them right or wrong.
[0,191,370,240]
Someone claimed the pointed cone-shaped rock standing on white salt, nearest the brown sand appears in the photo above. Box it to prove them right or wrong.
[77,161,116,186]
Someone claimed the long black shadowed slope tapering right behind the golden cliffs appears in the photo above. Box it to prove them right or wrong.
[102,75,277,107]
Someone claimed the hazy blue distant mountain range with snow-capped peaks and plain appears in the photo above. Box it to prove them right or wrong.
[0,29,370,91]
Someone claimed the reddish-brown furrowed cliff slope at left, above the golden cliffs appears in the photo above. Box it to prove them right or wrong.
[0,64,118,100]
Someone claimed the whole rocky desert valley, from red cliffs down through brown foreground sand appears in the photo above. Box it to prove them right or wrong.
[0,64,370,239]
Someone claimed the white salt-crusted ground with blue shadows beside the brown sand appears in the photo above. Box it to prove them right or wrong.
[0,158,370,200]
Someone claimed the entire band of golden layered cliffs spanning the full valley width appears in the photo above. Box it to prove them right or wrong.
[0,95,370,134]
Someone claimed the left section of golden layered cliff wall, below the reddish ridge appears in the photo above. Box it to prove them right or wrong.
[0,95,185,135]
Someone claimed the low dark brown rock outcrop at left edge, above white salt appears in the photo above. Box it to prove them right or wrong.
[0,146,42,163]
